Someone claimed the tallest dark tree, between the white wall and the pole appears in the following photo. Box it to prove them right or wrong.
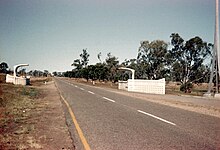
[169,33,212,83]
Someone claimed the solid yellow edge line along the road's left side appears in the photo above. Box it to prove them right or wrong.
[60,95,91,150]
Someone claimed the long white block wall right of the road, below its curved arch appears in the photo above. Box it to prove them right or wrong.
[118,78,166,94]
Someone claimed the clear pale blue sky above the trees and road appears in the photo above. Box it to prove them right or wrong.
[0,0,215,72]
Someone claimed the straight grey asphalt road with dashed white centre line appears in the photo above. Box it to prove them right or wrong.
[55,78,220,150]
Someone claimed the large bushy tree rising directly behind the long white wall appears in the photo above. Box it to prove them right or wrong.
[137,40,168,79]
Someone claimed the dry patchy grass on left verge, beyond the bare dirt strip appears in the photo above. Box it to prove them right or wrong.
[0,83,41,150]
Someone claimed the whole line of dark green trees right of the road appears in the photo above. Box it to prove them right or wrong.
[64,33,213,90]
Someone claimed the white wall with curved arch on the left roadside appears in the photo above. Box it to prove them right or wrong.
[6,64,30,85]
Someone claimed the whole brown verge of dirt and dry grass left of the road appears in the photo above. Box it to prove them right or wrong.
[0,81,74,150]
